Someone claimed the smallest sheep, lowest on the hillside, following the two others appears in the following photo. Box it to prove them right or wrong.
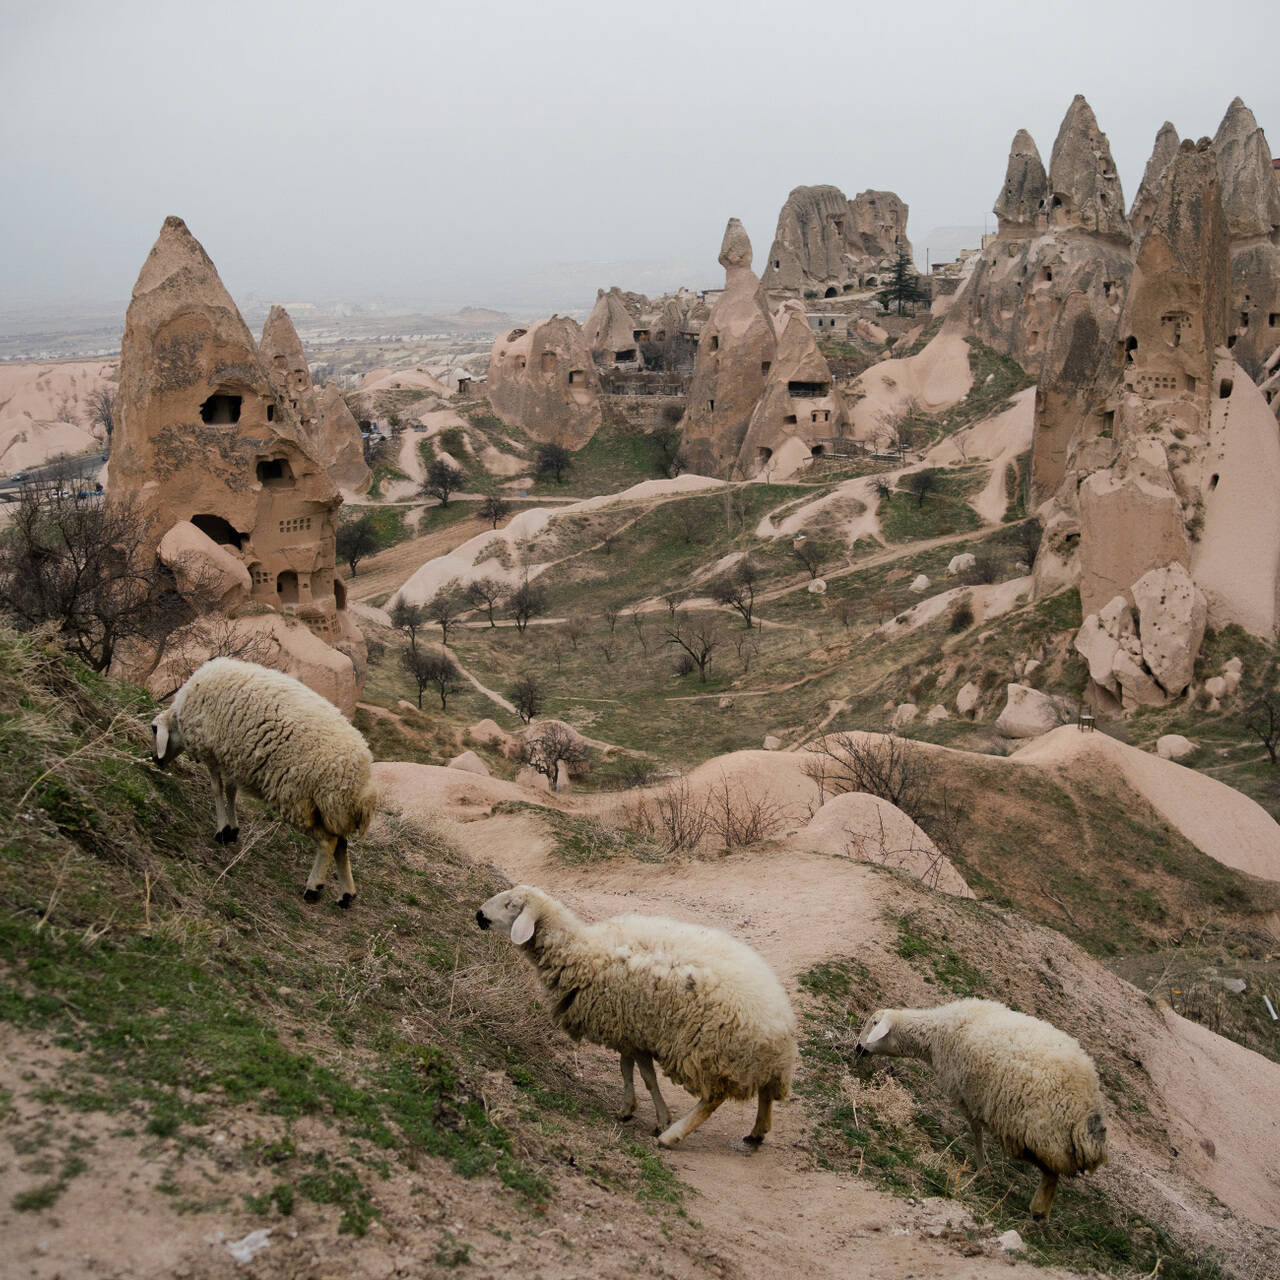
[858,1000,1107,1221]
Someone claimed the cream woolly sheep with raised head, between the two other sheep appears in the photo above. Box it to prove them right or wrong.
[476,884,796,1149]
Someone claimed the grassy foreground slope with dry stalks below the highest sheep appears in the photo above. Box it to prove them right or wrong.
[0,630,696,1259]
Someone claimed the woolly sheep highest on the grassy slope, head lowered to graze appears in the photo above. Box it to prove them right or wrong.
[151,658,378,908]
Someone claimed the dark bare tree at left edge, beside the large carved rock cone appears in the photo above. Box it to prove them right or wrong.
[0,470,186,671]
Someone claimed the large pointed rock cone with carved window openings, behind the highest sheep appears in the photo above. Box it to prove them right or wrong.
[108,218,362,708]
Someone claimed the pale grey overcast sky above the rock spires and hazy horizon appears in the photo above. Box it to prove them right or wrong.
[0,0,1280,317]
